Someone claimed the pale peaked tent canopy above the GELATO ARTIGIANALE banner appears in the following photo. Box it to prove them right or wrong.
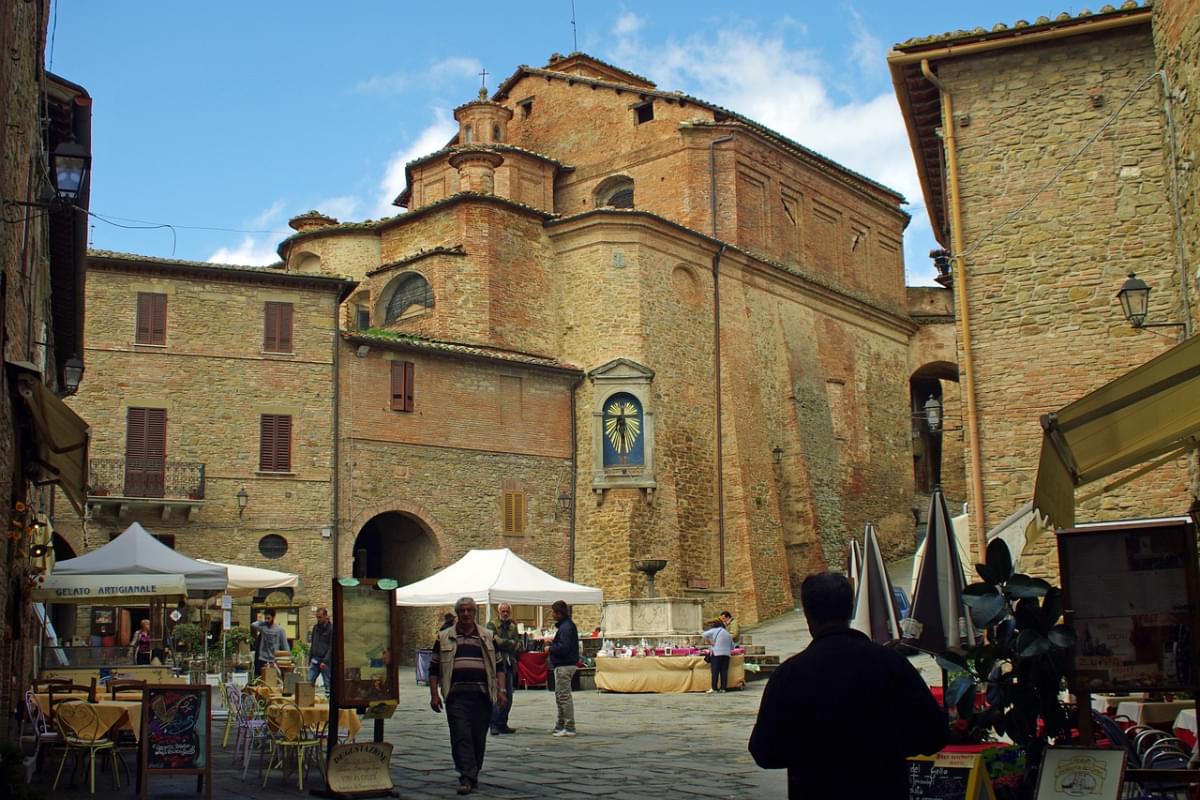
[50,523,229,594]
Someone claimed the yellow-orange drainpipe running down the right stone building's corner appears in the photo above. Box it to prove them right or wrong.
[920,59,988,559]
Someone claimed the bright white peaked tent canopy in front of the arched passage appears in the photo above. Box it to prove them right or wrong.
[396,547,604,606]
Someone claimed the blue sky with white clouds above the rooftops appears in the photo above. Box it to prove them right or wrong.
[47,0,1082,284]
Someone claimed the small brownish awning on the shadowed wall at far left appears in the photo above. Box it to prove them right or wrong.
[7,361,89,516]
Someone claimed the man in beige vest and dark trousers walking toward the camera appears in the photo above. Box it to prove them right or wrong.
[430,597,506,794]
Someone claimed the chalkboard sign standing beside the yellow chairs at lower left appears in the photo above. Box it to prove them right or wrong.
[140,684,212,800]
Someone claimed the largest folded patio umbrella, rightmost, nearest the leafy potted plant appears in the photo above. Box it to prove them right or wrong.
[904,487,976,652]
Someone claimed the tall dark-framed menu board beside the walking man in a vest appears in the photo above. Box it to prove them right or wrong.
[331,578,400,709]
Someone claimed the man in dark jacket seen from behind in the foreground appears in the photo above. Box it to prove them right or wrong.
[750,572,948,800]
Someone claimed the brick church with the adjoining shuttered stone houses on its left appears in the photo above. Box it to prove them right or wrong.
[58,53,956,652]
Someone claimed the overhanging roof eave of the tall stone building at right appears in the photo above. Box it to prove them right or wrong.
[888,0,1151,247]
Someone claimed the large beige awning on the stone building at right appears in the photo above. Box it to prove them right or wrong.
[1033,337,1200,528]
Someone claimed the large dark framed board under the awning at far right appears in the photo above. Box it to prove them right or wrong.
[1058,517,1200,693]
